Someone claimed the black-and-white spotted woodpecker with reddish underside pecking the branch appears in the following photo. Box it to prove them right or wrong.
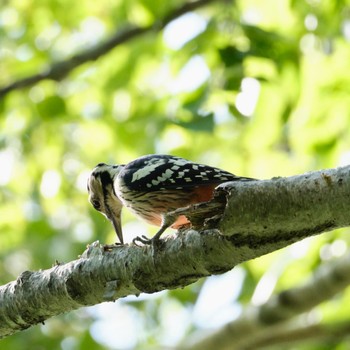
[87,154,254,244]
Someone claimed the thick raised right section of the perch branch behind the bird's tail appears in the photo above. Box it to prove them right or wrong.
[219,166,350,249]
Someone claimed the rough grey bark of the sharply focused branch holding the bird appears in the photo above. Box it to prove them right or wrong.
[0,167,350,337]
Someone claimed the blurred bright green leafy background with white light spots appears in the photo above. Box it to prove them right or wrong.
[0,0,350,350]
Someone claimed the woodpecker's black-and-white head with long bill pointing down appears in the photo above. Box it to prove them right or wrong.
[87,163,124,244]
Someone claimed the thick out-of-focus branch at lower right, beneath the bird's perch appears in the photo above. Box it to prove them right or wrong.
[186,250,350,350]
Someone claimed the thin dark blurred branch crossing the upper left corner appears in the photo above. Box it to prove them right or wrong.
[0,0,221,98]
